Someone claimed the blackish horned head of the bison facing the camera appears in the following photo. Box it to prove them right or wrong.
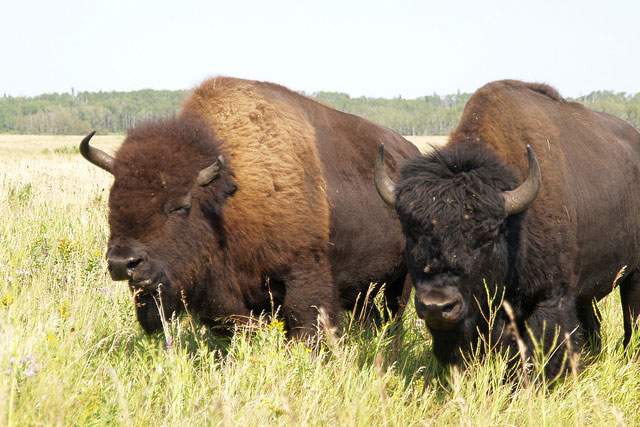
[375,142,541,363]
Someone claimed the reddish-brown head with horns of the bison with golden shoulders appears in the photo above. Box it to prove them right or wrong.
[80,117,235,332]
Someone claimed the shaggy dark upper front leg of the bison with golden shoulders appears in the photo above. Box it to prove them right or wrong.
[282,254,337,340]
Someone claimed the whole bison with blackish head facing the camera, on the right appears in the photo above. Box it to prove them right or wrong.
[376,81,640,376]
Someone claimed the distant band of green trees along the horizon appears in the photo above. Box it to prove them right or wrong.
[0,89,640,135]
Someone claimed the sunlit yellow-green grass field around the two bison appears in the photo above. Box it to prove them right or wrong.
[0,135,640,427]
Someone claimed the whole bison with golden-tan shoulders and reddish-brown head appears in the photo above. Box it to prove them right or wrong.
[80,78,417,337]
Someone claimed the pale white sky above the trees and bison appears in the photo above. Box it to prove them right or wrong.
[0,0,640,98]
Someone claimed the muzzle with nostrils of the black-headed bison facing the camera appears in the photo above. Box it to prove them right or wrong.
[416,287,465,329]
